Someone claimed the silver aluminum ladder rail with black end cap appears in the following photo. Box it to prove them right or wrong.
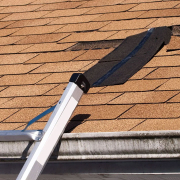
[16,73,89,180]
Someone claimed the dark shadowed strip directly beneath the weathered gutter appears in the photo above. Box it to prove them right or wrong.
[0,159,180,177]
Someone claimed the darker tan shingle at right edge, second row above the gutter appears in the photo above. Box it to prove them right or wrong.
[120,103,180,119]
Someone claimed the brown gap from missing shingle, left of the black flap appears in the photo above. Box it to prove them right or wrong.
[67,39,123,51]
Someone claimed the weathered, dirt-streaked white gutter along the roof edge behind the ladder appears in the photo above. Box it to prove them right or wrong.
[0,130,180,161]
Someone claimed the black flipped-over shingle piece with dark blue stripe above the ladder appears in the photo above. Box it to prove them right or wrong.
[84,27,171,87]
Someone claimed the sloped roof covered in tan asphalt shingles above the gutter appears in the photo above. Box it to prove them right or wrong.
[0,0,180,133]
